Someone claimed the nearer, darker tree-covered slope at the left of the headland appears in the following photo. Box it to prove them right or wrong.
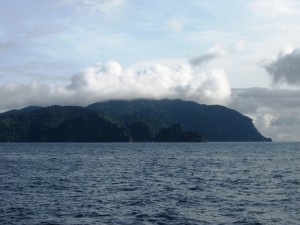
[0,106,130,142]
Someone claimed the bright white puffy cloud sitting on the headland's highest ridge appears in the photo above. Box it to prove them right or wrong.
[69,58,230,103]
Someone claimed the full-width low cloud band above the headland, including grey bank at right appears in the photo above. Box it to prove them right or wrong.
[0,56,300,141]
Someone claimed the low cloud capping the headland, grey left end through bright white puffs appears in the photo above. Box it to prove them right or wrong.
[0,57,231,111]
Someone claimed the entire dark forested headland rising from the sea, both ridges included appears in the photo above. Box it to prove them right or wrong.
[0,100,271,142]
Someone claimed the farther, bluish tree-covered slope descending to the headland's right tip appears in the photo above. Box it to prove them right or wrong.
[87,100,270,141]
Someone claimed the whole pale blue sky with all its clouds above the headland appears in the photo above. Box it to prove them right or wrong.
[0,0,300,141]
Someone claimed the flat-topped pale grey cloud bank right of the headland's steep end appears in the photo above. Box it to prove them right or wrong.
[228,88,300,141]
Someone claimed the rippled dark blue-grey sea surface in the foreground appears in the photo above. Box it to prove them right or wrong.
[0,143,300,225]
